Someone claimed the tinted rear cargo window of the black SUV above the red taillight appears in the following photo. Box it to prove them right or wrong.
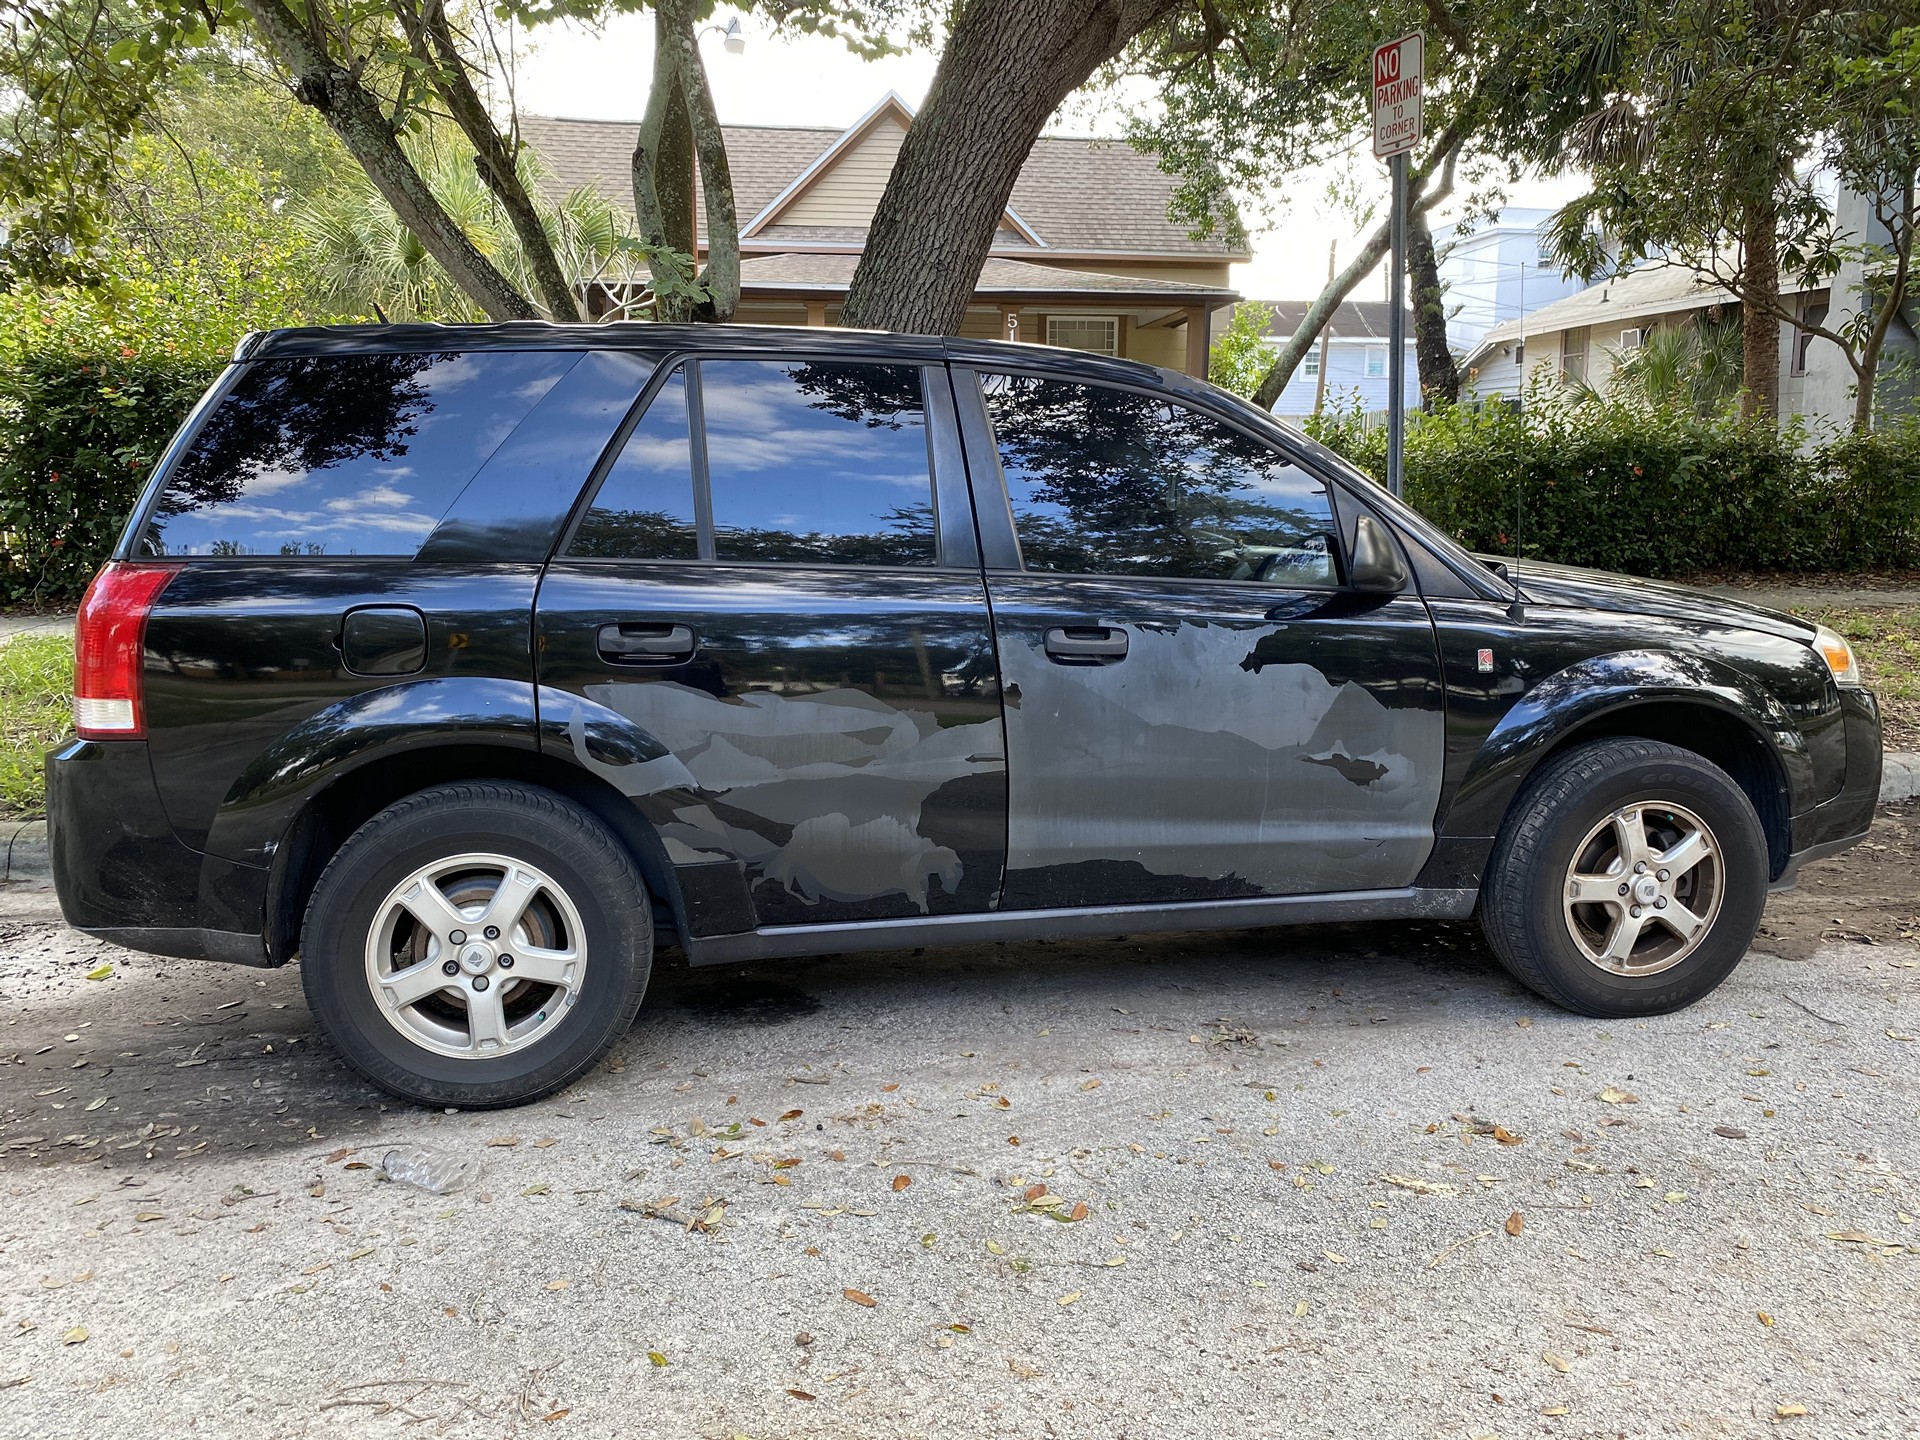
[142,351,580,555]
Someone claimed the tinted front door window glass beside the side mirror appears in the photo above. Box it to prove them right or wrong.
[985,384,1338,586]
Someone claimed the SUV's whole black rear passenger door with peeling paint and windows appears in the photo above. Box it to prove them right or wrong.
[536,349,1006,935]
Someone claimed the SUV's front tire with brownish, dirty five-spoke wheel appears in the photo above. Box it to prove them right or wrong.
[1480,739,1768,1020]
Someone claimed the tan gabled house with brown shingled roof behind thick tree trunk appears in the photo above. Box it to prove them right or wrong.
[520,94,1248,376]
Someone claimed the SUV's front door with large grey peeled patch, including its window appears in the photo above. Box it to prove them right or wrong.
[954,367,1446,910]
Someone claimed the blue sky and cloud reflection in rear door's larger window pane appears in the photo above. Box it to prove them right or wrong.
[701,361,931,536]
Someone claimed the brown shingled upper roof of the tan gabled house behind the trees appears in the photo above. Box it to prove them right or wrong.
[520,96,1248,259]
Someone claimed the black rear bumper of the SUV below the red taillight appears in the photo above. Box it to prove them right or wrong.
[46,739,269,966]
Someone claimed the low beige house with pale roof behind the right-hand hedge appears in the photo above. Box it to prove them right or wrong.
[1463,263,1851,417]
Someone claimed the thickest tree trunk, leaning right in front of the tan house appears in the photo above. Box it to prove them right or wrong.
[843,0,1177,334]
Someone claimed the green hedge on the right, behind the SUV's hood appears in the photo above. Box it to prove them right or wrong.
[1308,401,1920,576]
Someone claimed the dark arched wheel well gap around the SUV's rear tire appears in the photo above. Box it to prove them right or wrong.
[267,745,682,964]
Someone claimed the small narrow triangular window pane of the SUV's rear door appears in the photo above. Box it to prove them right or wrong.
[570,371,699,561]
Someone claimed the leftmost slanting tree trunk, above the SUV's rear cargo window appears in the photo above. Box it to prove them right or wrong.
[242,0,540,321]
